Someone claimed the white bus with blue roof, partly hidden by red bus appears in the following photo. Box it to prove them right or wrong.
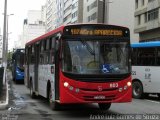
[131,41,160,98]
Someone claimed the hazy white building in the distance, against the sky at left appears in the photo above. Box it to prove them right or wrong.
[18,9,45,48]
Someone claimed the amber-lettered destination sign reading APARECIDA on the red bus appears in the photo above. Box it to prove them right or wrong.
[71,28,123,36]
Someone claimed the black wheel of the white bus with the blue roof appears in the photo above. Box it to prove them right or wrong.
[132,81,143,99]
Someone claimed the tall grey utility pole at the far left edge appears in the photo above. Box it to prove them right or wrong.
[2,0,7,65]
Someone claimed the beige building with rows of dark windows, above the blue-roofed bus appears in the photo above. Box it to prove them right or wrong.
[134,0,160,42]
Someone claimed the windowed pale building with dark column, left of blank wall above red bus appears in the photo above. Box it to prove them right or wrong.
[83,0,109,23]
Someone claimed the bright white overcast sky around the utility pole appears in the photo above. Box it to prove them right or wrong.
[0,0,46,50]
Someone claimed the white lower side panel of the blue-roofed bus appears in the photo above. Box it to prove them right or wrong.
[132,66,160,93]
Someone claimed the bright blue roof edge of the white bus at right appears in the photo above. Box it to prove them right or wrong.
[131,41,160,48]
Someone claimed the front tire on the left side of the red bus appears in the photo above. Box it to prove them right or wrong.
[48,88,60,110]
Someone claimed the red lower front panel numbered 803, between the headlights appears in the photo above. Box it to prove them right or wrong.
[60,73,132,103]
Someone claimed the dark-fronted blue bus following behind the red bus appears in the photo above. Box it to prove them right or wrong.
[12,49,25,83]
